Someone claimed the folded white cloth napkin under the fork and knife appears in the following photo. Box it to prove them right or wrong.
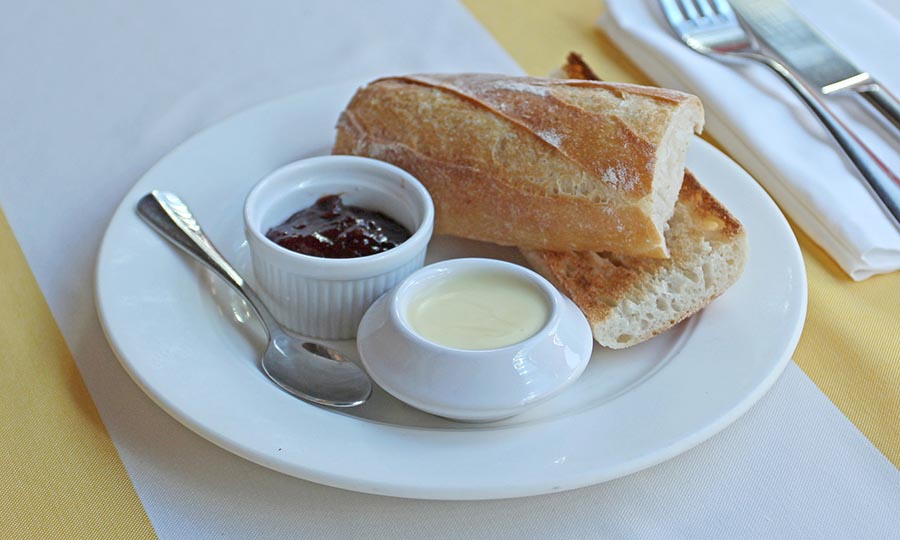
[598,0,900,280]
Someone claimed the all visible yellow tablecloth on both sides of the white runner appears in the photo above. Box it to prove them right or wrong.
[0,0,900,538]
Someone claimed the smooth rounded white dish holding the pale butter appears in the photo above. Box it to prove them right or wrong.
[357,259,593,422]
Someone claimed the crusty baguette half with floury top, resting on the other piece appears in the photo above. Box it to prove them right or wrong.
[333,74,703,258]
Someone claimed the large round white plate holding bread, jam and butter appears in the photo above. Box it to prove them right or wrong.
[96,81,806,499]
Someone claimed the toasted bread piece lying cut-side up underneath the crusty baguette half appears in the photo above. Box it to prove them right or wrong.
[521,55,748,349]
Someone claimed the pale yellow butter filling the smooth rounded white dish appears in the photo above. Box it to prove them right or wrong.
[406,270,550,350]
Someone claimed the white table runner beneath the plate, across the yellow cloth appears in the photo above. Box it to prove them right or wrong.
[0,0,900,539]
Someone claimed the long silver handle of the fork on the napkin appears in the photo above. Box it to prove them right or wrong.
[741,53,900,231]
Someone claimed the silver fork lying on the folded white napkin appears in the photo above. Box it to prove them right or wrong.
[659,0,900,231]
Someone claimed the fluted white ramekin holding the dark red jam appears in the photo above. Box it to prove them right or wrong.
[244,156,434,339]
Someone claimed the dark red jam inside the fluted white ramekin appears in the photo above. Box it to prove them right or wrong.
[266,195,410,259]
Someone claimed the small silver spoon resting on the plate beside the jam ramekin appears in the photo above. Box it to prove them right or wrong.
[137,190,372,407]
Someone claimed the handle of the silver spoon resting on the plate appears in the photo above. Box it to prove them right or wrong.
[137,189,278,335]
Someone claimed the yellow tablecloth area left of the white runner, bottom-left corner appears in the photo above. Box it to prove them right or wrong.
[0,213,155,539]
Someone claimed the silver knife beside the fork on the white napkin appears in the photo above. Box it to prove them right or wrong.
[732,0,900,134]
